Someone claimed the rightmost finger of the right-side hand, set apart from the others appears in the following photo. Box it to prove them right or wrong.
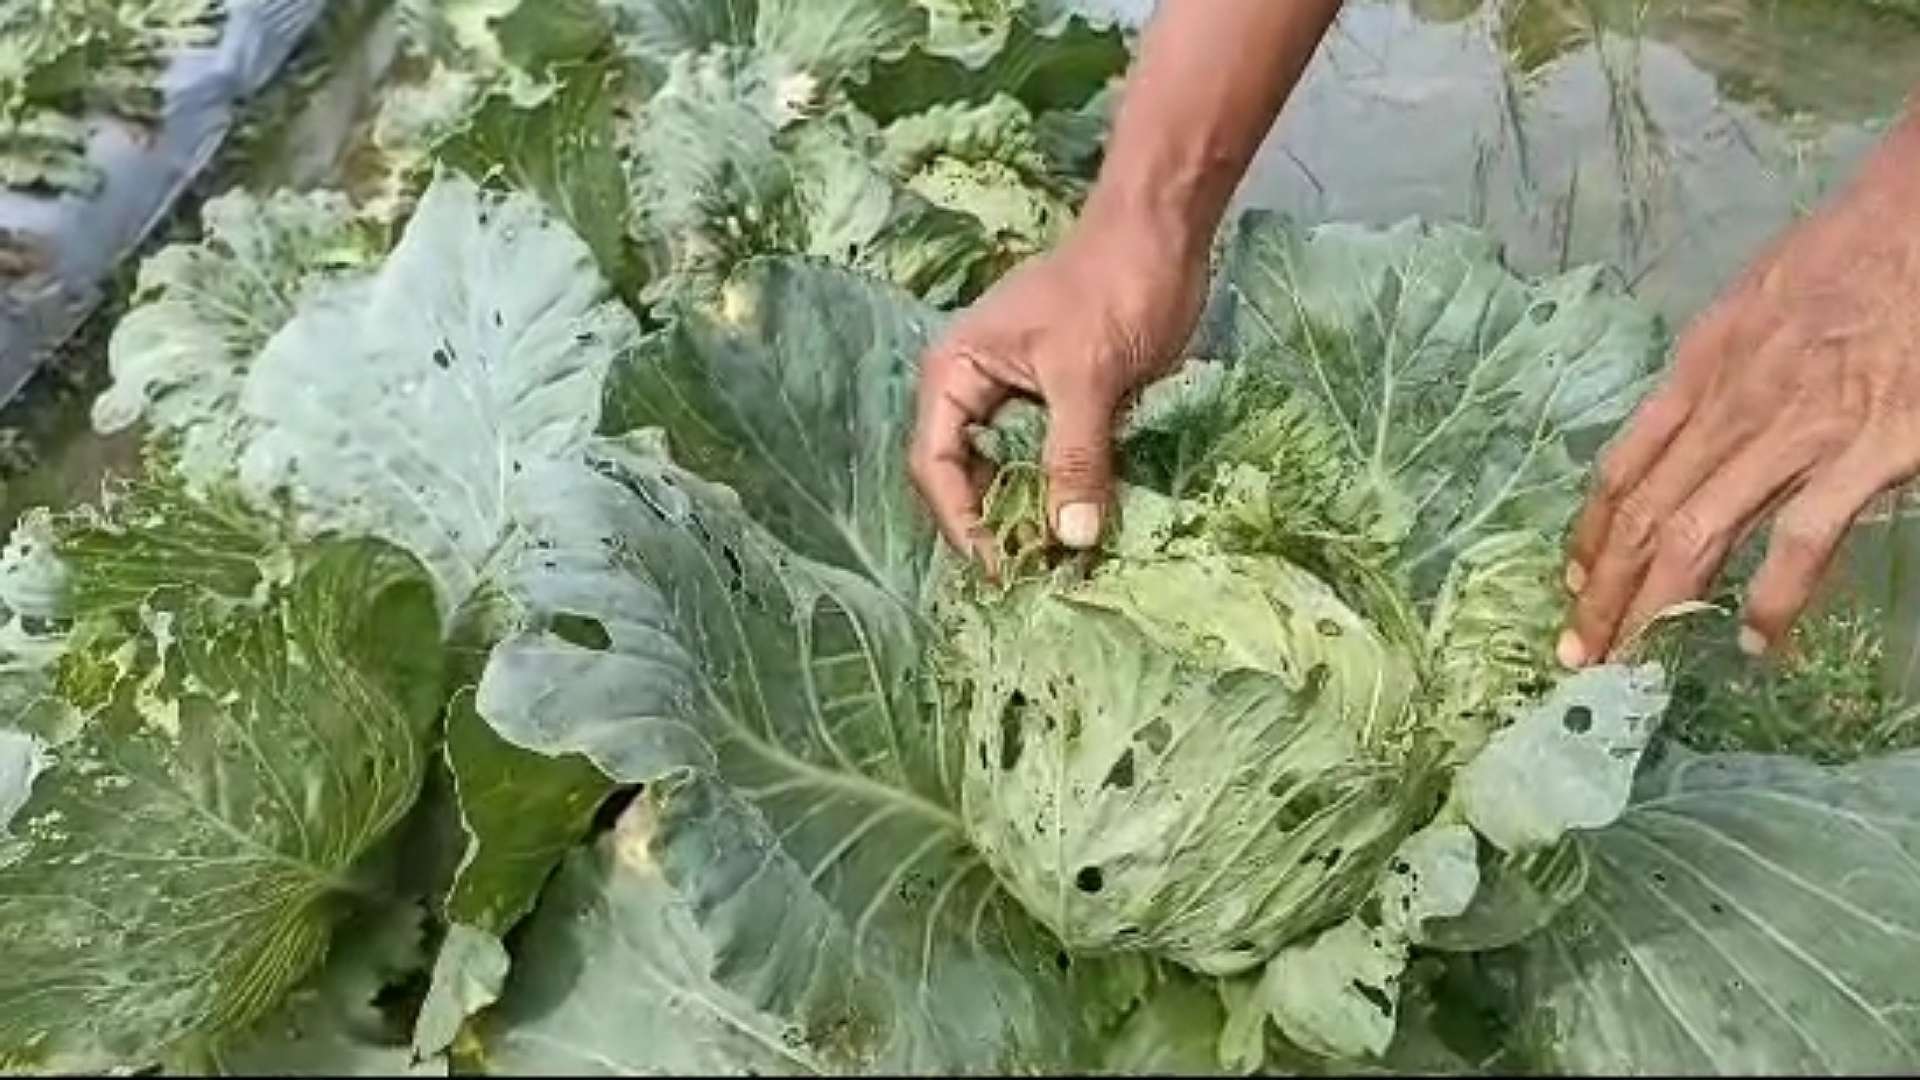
[1740,440,1912,655]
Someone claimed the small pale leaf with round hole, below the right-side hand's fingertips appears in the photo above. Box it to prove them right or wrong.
[1453,665,1667,853]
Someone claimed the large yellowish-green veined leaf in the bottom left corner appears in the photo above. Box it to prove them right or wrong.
[0,538,440,1070]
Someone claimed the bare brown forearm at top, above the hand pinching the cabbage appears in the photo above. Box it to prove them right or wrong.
[1087,0,1340,246]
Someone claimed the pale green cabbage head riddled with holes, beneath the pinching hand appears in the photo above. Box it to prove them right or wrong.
[947,457,1440,974]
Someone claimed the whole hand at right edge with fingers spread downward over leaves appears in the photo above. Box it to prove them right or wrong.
[1559,125,1920,667]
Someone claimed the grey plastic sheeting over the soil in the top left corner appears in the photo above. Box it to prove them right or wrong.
[0,0,326,404]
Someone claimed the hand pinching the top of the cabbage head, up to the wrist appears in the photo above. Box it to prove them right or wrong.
[908,213,1208,567]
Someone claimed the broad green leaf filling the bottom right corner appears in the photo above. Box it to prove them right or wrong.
[1519,749,1920,1074]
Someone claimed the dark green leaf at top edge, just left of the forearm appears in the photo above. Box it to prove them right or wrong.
[852,0,1131,123]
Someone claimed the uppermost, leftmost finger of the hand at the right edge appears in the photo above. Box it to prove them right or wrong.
[1567,311,1732,594]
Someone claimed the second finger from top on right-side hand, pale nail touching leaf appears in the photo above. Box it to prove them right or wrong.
[1557,411,1738,667]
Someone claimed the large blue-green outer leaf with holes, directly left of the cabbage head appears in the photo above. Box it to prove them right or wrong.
[478,438,1102,1070]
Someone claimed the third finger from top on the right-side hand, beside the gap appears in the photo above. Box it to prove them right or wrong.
[1617,442,1816,640]
